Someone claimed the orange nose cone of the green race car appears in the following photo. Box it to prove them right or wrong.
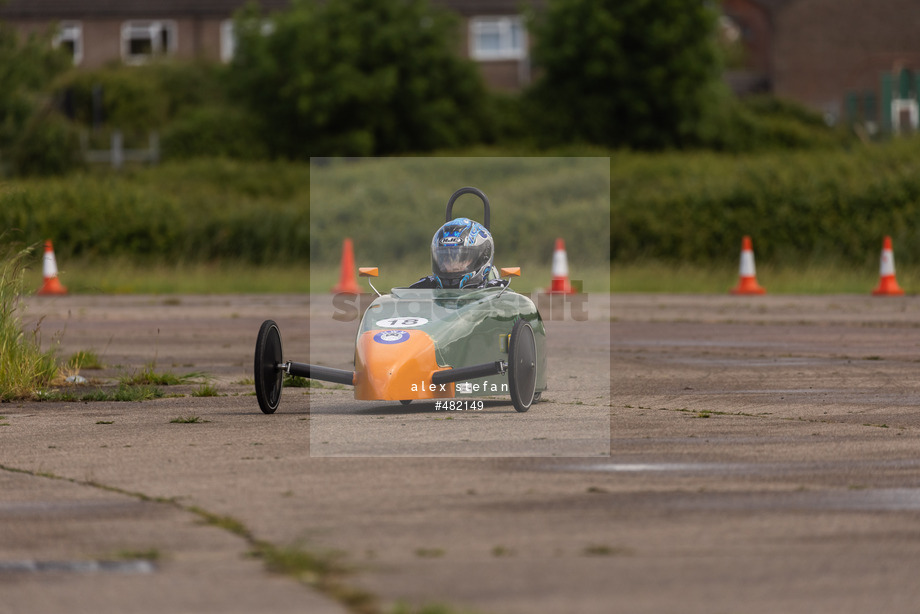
[355,329,454,401]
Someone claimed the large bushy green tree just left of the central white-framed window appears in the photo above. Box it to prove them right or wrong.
[228,0,485,158]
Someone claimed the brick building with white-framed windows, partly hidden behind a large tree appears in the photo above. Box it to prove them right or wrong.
[0,0,539,90]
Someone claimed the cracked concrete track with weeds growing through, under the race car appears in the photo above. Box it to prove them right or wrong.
[0,295,920,614]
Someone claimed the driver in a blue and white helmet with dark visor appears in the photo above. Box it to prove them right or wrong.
[409,217,508,288]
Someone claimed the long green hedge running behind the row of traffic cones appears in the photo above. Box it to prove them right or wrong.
[0,138,920,267]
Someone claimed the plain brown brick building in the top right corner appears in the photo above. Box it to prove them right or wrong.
[722,0,920,126]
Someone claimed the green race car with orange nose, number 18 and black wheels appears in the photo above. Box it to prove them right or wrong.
[254,188,546,414]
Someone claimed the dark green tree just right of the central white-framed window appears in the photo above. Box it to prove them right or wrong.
[528,0,727,149]
